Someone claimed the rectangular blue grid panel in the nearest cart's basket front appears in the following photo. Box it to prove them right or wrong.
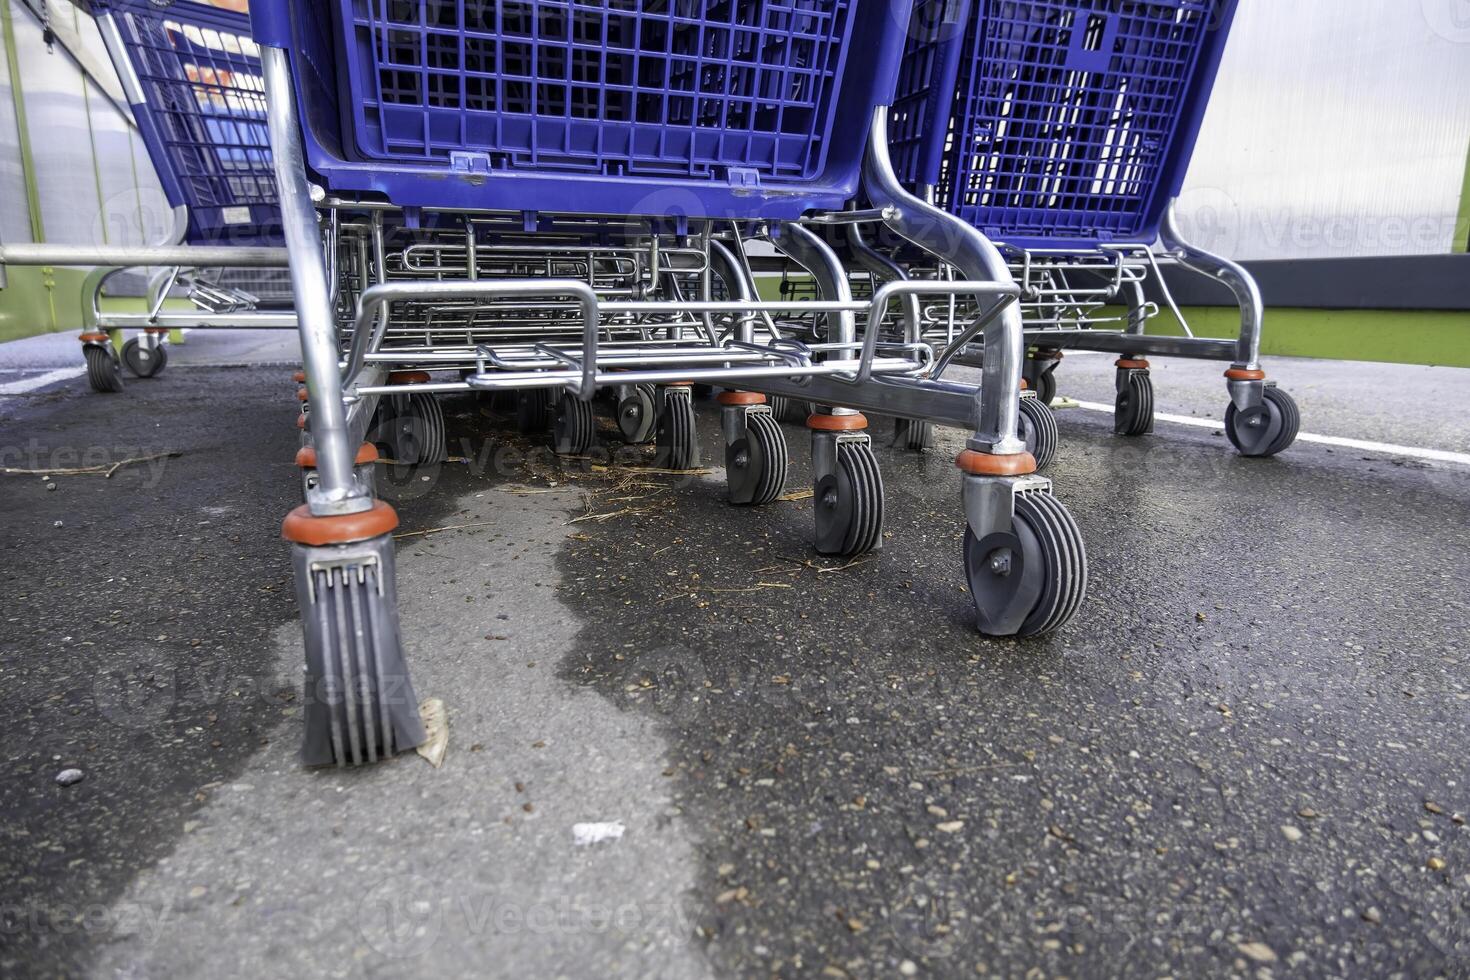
[337,0,856,182]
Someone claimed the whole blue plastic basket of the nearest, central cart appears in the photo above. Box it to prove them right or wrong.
[253,0,908,217]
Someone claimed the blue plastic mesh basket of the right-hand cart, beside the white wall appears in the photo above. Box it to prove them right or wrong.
[901,0,1233,242]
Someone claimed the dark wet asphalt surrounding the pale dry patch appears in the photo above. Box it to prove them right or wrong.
[0,343,1470,977]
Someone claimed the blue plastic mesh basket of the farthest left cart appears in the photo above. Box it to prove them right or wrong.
[109,0,281,244]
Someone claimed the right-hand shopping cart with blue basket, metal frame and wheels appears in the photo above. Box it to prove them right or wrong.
[870,0,1299,455]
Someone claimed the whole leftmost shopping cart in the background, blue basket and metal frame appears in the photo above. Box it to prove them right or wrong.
[82,0,295,391]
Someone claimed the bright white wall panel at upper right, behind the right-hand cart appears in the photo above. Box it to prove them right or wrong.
[1180,0,1470,259]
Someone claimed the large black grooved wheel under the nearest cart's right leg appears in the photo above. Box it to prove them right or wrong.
[964,491,1088,636]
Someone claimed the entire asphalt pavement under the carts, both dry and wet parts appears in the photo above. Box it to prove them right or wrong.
[0,335,1470,977]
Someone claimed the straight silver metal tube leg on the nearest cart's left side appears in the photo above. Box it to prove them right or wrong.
[260,47,372,516]
